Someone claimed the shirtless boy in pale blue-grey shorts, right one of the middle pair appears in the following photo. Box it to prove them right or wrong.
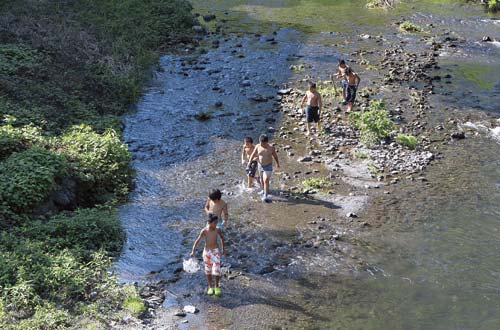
[247,134,280,202]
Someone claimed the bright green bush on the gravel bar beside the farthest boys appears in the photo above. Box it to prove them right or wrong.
[349,100,394,147]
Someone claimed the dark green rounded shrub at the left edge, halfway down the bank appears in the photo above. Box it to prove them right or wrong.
[0,147,67,213]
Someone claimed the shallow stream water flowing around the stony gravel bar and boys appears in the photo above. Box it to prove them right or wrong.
[116,0,500,329]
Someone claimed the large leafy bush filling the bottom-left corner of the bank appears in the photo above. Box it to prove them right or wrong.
[0,209,125,325]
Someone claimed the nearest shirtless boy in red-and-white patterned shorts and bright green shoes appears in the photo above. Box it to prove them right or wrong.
[189,214,225,296]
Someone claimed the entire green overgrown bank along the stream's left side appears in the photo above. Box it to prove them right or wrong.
[0,0,194,330]
